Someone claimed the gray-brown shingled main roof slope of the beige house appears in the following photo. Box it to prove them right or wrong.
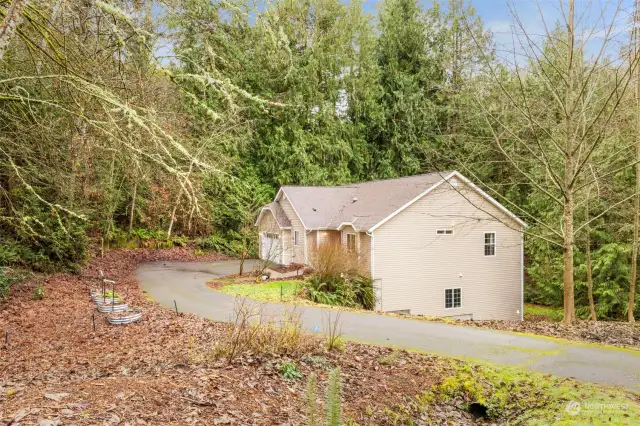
[278,171,451,231]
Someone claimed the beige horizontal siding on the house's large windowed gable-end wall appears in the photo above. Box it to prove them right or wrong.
[373,183,522,320]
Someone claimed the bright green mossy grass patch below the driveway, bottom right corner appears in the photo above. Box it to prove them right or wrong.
[416,359,640,425]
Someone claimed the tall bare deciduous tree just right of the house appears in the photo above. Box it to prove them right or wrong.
[464,0,638,323]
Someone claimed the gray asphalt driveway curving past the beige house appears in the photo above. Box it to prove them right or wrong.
[138,261,640,392]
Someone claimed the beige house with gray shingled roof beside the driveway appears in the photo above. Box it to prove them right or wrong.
[256,171,526,320]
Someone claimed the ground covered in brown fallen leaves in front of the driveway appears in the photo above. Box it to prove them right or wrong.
[0,248,640,425]
